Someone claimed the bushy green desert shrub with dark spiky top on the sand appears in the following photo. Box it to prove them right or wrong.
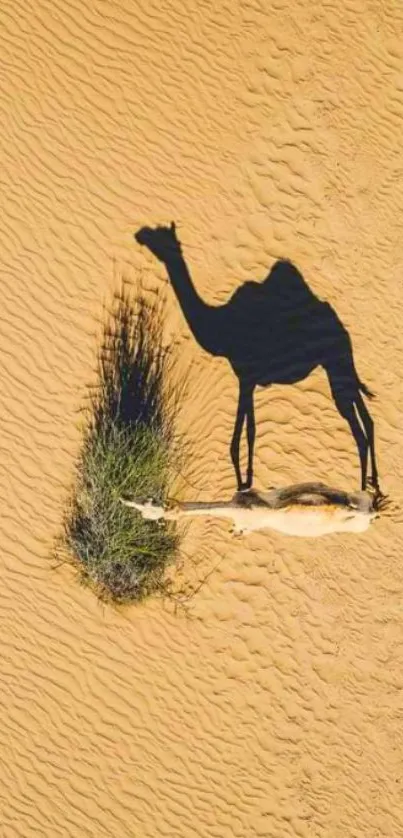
[62,291,179,603]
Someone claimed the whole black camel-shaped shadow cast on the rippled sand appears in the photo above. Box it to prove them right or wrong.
[135,223,379,491]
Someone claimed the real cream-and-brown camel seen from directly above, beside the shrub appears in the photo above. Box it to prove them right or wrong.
[121,483,386,537]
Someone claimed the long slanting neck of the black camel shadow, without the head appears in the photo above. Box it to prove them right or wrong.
[165,253,226,355]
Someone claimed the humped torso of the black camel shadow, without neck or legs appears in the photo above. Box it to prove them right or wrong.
[221,259,340,386]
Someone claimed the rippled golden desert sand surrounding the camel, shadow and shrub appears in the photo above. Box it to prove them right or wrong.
[0,0,403,838]
